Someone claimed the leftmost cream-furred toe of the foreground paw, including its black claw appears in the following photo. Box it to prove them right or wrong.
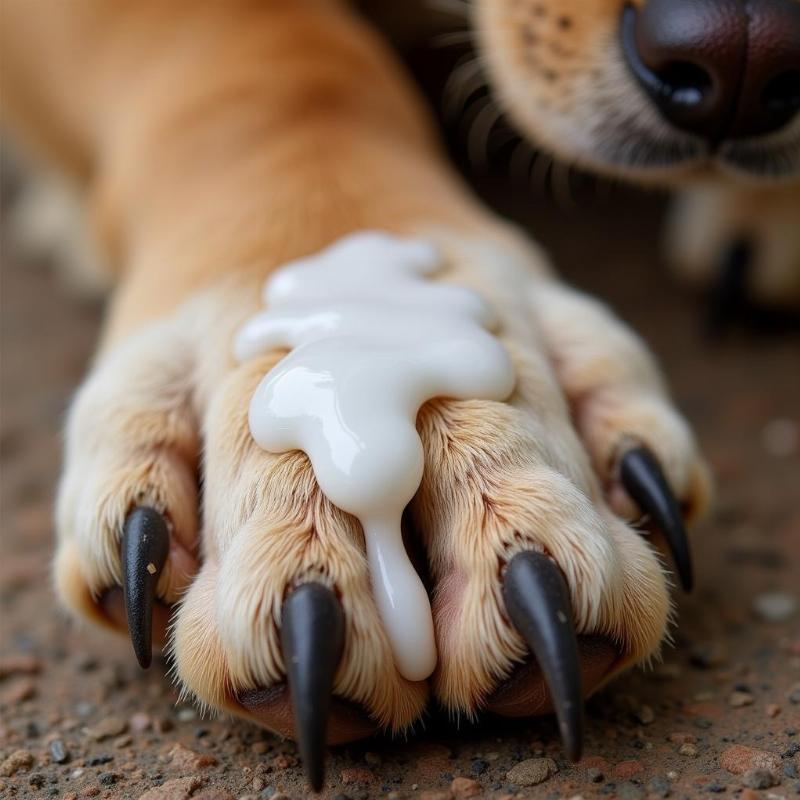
[55,321,200,666]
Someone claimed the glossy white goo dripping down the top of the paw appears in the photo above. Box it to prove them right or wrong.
[236,232,515,680]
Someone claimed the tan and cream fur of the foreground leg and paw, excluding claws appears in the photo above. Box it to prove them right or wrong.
[1,0,707,730]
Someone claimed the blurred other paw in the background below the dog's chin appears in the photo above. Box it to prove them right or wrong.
[666,184,800,322]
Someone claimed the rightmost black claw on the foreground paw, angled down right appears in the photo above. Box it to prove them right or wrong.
[620,447,694,592]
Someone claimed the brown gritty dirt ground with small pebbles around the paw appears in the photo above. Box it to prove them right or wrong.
[0,159,800,800]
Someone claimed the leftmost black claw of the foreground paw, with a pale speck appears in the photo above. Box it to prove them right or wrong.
[122,506,169,669]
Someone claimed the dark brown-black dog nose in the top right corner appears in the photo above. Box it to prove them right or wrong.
[622,0,800,141]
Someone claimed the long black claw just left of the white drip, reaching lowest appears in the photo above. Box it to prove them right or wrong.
[281,583,344,792]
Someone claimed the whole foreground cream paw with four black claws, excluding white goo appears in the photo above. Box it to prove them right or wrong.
[55,231,708,788]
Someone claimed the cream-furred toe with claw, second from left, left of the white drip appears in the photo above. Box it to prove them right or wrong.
[173,340,428,752]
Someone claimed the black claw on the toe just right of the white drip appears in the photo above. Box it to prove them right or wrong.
[503,551,583,761]
